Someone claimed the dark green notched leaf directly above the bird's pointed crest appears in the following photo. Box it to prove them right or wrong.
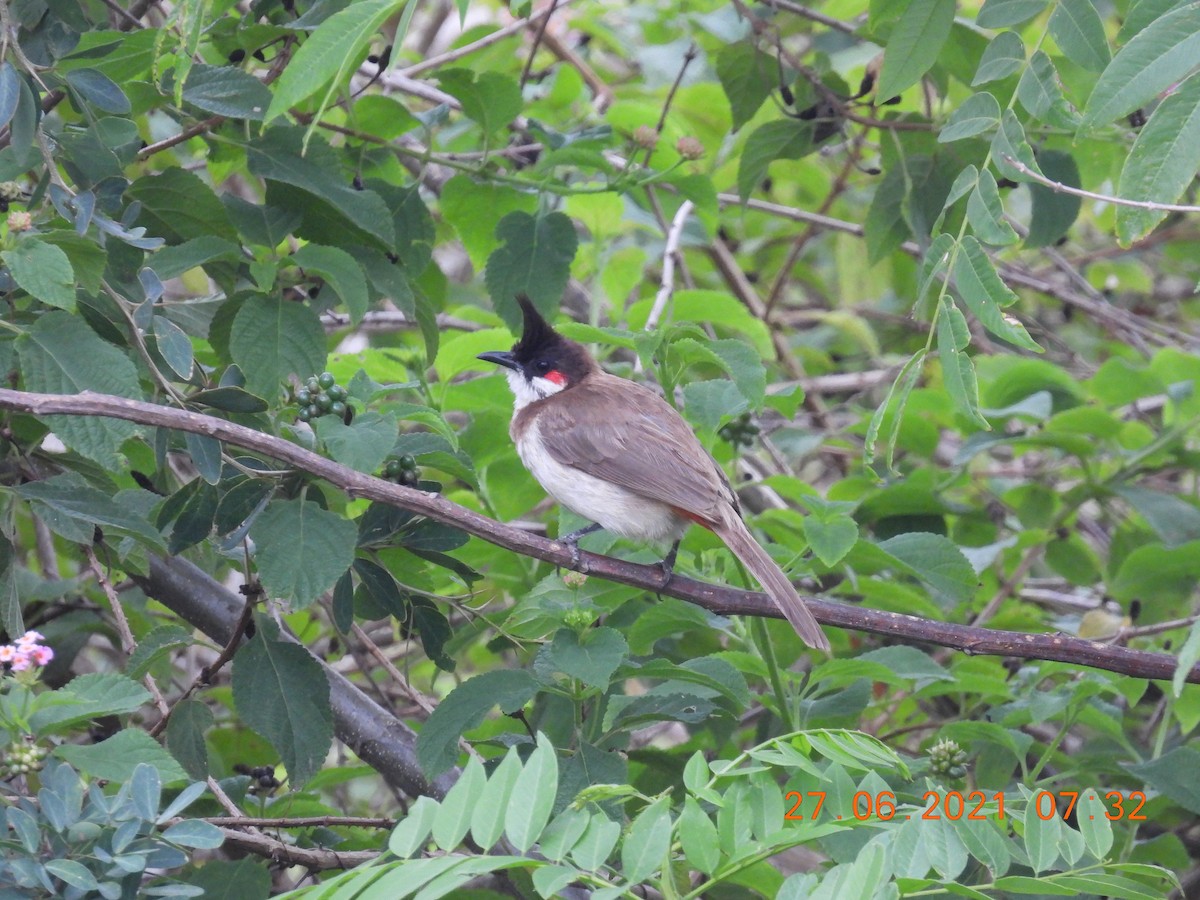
[484,212,578,334]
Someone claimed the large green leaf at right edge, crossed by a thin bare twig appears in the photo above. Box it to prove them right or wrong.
[1117,74,1200,246]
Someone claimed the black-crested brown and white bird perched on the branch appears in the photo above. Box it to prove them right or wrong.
[478,295,829,650]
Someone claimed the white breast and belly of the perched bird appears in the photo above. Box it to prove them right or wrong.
[517,419,689,542]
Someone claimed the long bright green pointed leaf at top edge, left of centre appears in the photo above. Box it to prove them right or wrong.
[264,0,407,124]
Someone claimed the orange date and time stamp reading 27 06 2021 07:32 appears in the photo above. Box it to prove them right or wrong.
[784,791,1146,822]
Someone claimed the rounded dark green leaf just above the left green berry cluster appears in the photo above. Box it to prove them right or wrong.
[229,296,325,397]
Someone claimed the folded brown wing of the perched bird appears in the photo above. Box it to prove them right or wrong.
[538,373,737,522]
